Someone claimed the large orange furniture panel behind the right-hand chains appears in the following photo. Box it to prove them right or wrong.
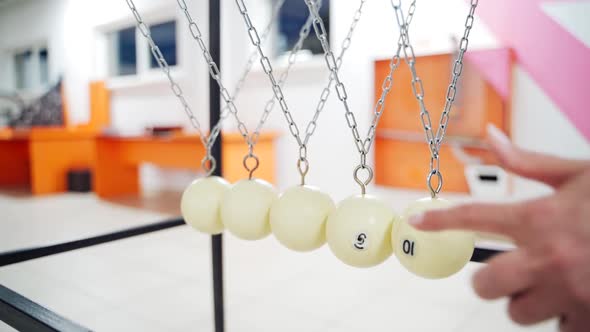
[375,50,511,192]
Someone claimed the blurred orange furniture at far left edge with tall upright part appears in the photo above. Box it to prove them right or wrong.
[0,82,109,195]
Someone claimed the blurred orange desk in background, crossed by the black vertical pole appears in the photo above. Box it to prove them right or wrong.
[94,133,277,198]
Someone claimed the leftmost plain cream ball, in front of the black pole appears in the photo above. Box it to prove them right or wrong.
[180,176,230,234]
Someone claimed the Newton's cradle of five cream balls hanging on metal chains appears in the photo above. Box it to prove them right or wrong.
[127,0,500,330]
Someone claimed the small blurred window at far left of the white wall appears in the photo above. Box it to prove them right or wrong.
[13,47,49,90]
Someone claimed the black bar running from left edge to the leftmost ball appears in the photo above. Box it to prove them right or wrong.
[0,218,185,267]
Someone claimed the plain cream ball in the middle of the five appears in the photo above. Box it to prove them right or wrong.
[270,186,334,251]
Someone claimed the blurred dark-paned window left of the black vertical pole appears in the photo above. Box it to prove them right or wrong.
[108,20,177,76]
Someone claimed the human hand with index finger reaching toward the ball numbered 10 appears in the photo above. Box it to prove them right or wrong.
[410,126,590,332]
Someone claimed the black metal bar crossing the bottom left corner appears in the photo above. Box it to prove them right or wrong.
[0,285,90,332]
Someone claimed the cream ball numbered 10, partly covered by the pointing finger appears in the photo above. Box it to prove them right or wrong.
[391,198,475,279]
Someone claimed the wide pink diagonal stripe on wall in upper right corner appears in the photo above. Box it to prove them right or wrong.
[476,0,590,140]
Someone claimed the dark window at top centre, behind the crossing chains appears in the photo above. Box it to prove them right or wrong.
[275,0,330,54]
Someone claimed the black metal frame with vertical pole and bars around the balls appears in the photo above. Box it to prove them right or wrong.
[0,0,501,332]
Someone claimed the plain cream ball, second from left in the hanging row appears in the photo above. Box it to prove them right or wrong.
[221,179,277,240]
